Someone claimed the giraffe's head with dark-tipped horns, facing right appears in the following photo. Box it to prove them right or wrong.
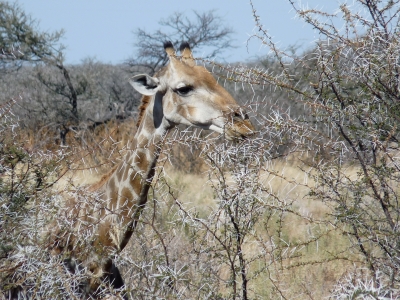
[130,42,254,139]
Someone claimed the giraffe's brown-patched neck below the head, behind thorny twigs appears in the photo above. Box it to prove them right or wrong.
[99,95,171,251]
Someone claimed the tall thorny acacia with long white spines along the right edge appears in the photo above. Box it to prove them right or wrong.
[234,0,400,299]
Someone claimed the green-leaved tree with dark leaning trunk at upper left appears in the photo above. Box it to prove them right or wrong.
[0,2,94,144]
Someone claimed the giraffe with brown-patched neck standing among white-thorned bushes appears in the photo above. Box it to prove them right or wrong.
[50,42,254,298]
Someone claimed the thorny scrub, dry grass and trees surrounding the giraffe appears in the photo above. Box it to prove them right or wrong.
[0,0,400,299]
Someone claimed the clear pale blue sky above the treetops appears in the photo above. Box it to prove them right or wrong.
[11,0,339,63]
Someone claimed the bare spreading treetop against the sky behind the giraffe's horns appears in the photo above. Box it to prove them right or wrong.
[127,10,234,73]
